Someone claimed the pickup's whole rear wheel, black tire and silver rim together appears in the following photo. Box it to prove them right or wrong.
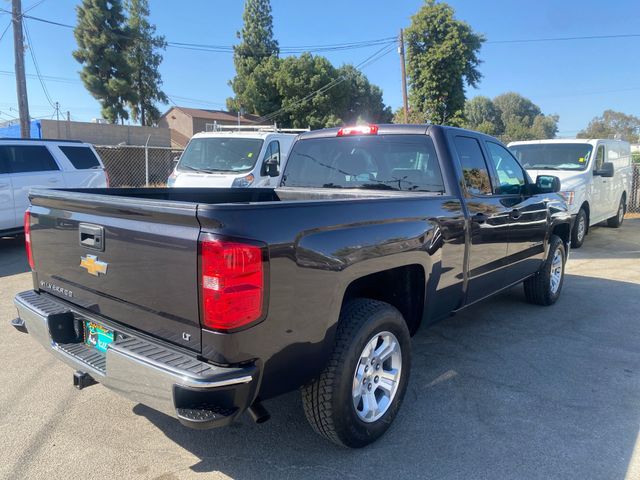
[302,299,411,448]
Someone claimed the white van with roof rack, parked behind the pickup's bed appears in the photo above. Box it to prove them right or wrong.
[167,126,307,188]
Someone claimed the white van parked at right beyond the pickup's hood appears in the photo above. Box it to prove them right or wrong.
[509,139,633,248]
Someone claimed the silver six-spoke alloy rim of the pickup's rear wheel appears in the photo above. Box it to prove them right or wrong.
[351,331,402,423]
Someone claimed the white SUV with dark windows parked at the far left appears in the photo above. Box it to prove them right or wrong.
[0,138,109,235]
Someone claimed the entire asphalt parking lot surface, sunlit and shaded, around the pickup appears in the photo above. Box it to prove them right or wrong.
[0,219,640,479]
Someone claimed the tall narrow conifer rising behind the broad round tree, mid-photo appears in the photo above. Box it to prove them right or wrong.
[227,0,280,113]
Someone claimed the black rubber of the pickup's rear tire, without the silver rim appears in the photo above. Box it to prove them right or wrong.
[302,299,411,448]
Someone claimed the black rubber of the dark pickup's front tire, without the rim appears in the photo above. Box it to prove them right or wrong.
[524,235,567,305]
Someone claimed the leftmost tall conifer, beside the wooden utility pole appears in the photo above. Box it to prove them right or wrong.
[73,0,135,123]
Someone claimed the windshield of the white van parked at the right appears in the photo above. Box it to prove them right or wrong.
[509,143,593,170]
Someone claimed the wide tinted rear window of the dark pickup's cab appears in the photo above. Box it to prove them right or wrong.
[282,135,444,193]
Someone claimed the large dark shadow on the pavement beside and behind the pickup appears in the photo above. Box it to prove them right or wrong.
[134,275,640,479]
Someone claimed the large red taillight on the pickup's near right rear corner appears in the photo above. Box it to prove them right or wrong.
[199,234,265,331]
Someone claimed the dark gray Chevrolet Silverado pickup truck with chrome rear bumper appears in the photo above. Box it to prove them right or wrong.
[13,125,570,447]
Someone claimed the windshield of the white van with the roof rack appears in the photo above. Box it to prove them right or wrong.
[178,137,262,173]
